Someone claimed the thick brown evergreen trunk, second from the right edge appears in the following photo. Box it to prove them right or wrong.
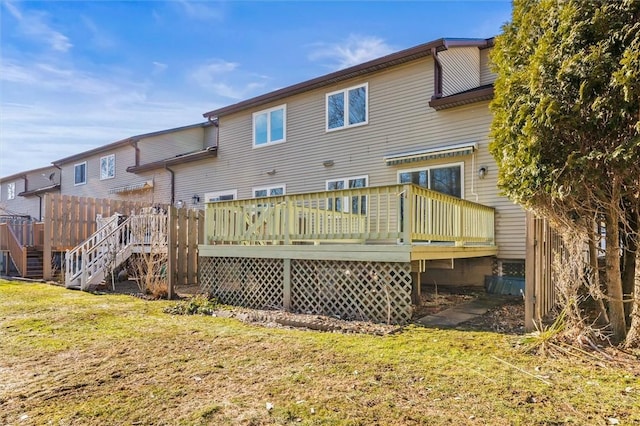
[605,208,627,343]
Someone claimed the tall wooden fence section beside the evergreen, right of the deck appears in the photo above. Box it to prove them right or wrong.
[525,212,562,332]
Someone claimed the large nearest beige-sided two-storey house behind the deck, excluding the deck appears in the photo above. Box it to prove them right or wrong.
[196,39,525,322]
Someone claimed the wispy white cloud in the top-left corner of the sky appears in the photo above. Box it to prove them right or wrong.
[3,2,73,52]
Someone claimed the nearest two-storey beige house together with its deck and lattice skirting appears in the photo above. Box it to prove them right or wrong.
[194,39,525,322]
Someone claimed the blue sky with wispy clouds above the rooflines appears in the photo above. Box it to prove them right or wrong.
[0,0,511,176]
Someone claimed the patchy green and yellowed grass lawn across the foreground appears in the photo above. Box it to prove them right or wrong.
[0,280,640,425]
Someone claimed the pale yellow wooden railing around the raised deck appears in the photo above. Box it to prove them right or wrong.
[205,184,494,245]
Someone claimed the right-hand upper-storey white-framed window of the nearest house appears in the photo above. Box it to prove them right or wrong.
[327,83,369,131]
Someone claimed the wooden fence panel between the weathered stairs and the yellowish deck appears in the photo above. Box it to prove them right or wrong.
[167,207,204,297]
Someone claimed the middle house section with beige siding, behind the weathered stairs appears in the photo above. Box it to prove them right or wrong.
[53,122,216,204]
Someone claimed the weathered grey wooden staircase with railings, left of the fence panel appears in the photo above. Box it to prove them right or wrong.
[65,214,167,290]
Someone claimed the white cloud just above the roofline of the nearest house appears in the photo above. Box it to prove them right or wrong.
[309,34,395,69]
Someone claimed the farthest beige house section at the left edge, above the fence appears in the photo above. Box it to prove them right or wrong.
[0,166,60,221]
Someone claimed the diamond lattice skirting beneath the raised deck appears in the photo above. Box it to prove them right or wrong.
[200,257,413,324]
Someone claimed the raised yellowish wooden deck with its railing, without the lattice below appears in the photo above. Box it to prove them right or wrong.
[199,185,498,262]
